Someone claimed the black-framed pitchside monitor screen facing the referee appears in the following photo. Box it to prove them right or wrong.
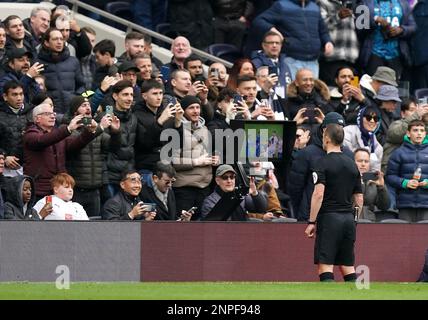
[231,120,294,162]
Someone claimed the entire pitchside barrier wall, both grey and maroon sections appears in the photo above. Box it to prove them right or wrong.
[0,221,428,282]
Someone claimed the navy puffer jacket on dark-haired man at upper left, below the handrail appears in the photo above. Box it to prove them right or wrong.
[39,47,85,114]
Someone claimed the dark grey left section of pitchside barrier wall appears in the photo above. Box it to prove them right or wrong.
[0,221,141,282]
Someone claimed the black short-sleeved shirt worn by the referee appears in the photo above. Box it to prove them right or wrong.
[312,152,363,213]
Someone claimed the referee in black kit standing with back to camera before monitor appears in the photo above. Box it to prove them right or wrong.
[305,124,363,281]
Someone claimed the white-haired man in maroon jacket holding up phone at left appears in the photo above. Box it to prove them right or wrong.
[23,104,102,200]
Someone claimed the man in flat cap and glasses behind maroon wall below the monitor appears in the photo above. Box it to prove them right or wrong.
[201,164,267,221]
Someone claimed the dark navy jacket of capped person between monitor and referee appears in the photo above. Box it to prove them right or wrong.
[287,127,354,221]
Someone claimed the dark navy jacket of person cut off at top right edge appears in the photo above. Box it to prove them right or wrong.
[412,0,428,66]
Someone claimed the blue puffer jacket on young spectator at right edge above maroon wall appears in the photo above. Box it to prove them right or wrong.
[386,136,428,209]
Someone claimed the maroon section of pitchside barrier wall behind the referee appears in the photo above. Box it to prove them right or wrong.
[141,222,428,282]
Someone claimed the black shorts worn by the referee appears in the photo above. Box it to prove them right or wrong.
[314,212,356,266]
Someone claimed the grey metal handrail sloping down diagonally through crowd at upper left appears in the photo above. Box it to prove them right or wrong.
[66,0,233,68]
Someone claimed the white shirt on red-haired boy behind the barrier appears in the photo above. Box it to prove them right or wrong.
[33,196,89,220]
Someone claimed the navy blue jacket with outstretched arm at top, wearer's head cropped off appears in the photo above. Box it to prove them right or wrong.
[253,0,331,61]
